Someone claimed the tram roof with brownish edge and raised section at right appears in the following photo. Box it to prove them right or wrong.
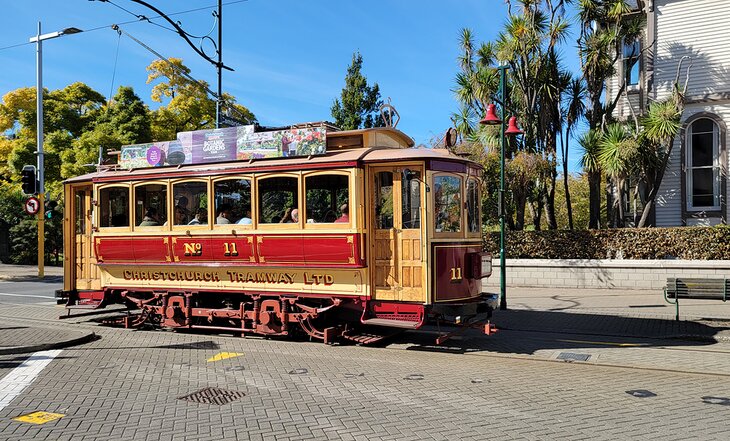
[65,128,477,183]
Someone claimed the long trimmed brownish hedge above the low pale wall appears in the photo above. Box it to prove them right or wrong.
[484,226,730,260]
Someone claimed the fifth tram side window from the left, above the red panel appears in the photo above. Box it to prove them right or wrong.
[258,176,299,224]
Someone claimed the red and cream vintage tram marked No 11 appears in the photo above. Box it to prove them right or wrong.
[59,123,497,343]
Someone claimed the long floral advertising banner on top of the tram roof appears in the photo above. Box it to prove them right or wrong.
[119,125,327,169]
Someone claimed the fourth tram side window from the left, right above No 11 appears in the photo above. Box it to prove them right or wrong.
[213,179,253,225]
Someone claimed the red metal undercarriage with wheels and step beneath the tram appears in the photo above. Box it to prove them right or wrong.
[78,290,426,344]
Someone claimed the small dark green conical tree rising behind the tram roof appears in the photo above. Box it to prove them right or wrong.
[331,52,385,130]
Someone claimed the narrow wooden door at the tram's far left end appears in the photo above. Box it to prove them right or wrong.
[69,185,101,290]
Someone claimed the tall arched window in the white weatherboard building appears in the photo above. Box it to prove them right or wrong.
[685,118,722,211]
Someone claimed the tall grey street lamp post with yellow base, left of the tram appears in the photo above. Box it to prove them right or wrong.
[29,22,81,279]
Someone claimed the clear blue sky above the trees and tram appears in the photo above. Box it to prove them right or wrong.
[0,0,578,168]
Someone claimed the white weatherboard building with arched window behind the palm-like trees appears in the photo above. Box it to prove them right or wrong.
[606,0,730,227]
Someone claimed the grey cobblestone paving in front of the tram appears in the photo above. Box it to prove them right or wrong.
[0,329,730,440]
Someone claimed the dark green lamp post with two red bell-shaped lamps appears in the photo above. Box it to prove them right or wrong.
[479,64,522,310]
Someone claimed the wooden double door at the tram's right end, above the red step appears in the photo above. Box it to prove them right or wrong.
[369,167,426,302]
